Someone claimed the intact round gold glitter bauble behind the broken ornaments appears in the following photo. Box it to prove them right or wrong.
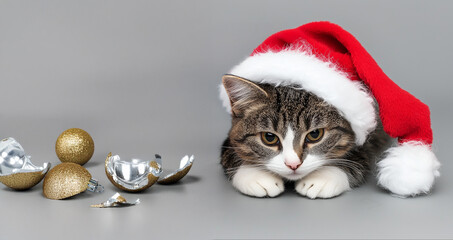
[55,128,94,165]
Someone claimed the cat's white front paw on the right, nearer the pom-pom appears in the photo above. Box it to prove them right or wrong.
[296,166,351,199]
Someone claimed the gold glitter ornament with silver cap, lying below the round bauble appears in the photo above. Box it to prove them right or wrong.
[43,162,104,199]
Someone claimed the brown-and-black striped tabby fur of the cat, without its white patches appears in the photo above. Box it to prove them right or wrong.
[221,76,390,191]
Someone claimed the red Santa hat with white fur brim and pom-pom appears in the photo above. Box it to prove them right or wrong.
[220,22,440,196]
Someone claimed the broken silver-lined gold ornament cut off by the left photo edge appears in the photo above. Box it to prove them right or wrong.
[0,137,50,190]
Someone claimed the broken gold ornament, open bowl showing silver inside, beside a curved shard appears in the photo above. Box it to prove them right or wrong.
[105,153,162,192]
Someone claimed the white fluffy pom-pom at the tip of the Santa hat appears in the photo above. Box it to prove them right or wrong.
[377,141,440,197]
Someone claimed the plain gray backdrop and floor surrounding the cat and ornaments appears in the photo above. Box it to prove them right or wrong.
[0,1,453,239]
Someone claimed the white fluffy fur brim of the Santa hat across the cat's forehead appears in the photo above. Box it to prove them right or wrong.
[220,49,377,145]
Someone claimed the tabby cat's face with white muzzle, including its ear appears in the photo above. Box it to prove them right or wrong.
[223,75,355,180]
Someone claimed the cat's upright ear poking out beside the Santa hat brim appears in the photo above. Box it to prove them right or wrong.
[222,74,268,115]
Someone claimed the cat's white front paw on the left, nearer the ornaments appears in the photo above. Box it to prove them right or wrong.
[232,166,285,197]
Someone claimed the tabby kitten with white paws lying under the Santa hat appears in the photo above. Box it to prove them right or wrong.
[221,75,391,199]
